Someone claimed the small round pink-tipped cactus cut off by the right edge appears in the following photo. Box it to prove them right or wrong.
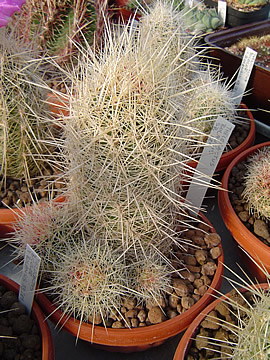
[242,147,270,220]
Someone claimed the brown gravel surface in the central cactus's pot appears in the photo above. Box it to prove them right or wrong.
[41,223,222,328]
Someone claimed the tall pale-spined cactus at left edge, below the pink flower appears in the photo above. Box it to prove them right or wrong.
[0,24,54,186]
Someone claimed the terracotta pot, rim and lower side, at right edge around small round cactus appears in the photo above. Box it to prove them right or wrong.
[218,141,270,282]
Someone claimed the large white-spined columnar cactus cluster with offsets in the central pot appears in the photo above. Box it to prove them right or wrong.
[10,1,230,336]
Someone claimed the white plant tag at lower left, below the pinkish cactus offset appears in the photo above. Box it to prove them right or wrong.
[19,244,41,314]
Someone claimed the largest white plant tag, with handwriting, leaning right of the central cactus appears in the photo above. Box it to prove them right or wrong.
[186,116,234,215]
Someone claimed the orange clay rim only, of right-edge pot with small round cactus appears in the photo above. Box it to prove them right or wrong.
[218,141,270,264]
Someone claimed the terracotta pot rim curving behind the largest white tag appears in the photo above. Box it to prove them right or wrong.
[188,103,255,172]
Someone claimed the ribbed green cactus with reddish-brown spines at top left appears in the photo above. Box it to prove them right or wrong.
[13,0,95,61]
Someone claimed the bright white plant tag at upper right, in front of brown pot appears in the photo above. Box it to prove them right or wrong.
[233,46,257,105]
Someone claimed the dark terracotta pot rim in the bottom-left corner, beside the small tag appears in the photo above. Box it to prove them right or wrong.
[0,274,54,360]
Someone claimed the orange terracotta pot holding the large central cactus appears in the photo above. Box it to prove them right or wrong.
[36,215,223,352]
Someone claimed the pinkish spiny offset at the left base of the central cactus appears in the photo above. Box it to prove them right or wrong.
[11,202,78,273]
